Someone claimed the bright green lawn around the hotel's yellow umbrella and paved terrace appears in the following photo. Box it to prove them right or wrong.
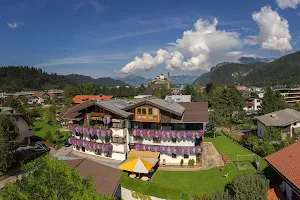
[121,136,267,199]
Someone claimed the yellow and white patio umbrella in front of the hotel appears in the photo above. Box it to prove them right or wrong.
[119,157,156,174]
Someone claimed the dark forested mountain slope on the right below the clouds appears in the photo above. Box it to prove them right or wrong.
[194,51,300,86]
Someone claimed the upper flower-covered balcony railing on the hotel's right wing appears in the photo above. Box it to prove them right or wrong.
[132,129,204,139]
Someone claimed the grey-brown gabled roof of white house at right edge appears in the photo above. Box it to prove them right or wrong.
[256,108,300,126]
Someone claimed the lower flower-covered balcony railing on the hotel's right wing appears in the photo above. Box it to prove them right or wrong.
[135,144,202,155]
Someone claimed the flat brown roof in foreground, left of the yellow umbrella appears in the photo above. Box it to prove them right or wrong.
[65,159,121,197]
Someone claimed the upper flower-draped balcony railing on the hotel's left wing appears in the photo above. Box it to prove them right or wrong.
[69,125,113,137]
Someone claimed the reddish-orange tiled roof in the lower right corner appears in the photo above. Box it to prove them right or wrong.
[266,141,300,192]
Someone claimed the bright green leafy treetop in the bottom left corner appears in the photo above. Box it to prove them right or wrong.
[2,155,113,200]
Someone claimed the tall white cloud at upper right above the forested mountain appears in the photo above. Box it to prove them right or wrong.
[244,6,292,52]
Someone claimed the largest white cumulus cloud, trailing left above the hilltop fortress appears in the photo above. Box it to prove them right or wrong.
[119,18,241,73]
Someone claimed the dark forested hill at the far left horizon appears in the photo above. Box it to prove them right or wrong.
[0,66,73,92]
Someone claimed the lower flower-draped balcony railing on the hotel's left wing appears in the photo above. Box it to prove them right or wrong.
[69,137,113,151]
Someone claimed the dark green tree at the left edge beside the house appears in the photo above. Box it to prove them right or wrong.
[0,114,20,172]
